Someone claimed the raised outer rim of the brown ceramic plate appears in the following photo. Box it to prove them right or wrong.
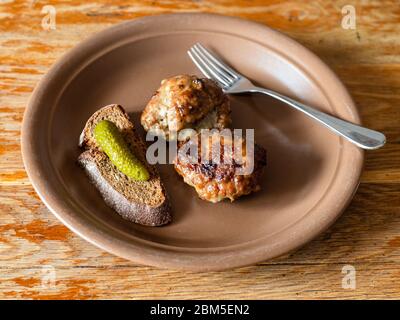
[21,13,364,271]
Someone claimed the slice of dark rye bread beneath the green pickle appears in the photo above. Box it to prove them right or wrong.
[78,104,171,226]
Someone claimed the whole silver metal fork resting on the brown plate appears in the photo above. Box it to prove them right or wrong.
[187,43,386,149]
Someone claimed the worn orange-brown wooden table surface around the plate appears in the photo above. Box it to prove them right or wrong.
[0,0,400,299]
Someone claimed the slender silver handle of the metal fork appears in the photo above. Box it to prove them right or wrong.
[250,87,386,149]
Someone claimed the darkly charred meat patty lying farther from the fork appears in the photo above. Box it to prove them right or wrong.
[174,133,266,202]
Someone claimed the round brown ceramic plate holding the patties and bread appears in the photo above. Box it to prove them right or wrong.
[22,14,363,270]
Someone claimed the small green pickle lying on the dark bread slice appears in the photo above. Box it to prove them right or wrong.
[93,120,150,181]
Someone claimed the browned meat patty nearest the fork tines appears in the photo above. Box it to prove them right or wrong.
[141,75,231,140]
